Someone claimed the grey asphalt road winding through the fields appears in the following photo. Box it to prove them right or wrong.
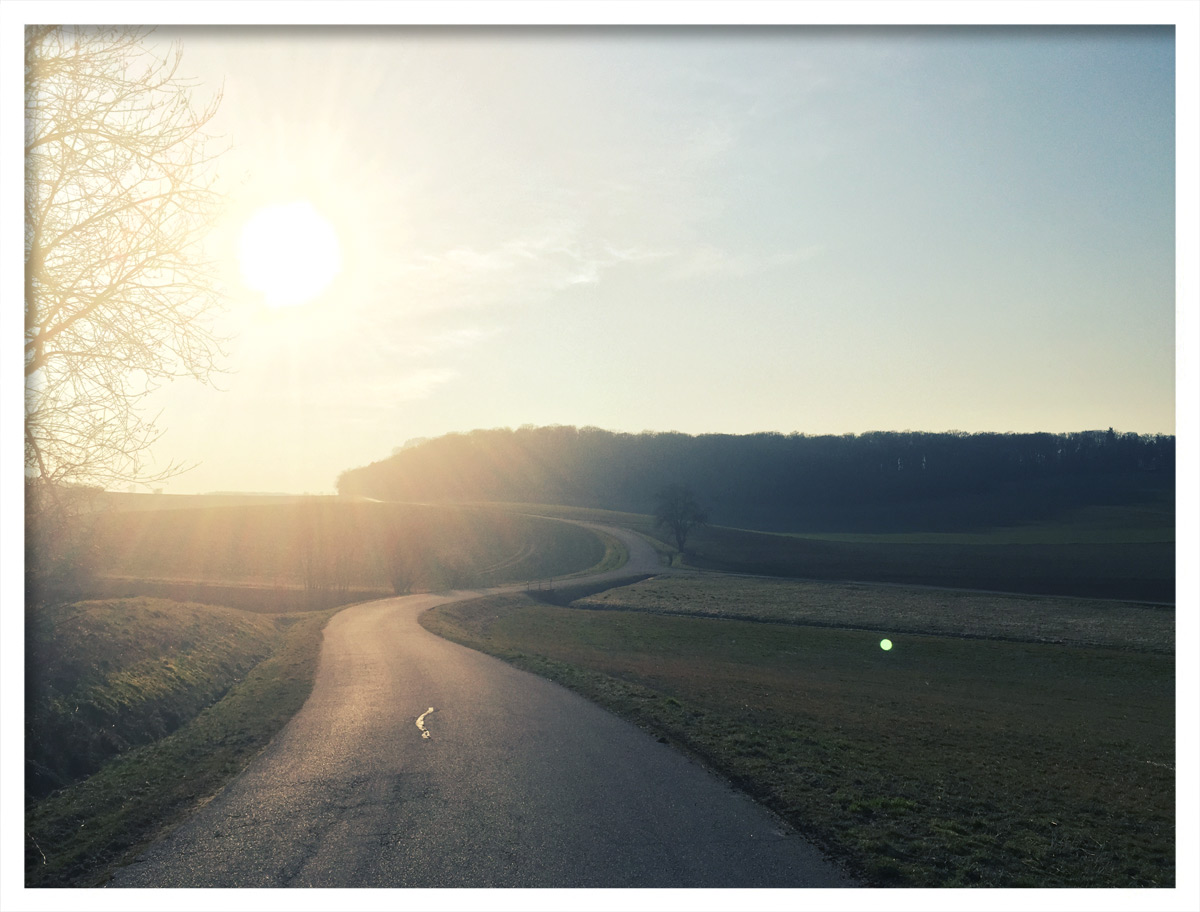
[109,527,853,888]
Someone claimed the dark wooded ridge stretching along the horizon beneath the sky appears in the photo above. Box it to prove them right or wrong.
[337,425,1175,532]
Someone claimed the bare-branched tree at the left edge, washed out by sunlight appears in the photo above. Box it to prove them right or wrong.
[25,25,221,488]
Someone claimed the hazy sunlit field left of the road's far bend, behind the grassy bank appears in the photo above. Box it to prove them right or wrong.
[84,497,605,607]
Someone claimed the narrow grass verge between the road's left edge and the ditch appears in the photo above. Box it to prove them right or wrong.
[25,606,337,887]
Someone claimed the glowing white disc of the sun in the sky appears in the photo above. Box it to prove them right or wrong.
[238,200,342,307]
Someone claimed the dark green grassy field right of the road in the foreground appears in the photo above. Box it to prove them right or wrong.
[421,583,1175,888]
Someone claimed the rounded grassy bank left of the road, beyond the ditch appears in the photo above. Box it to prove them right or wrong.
[25,599,281,802]
